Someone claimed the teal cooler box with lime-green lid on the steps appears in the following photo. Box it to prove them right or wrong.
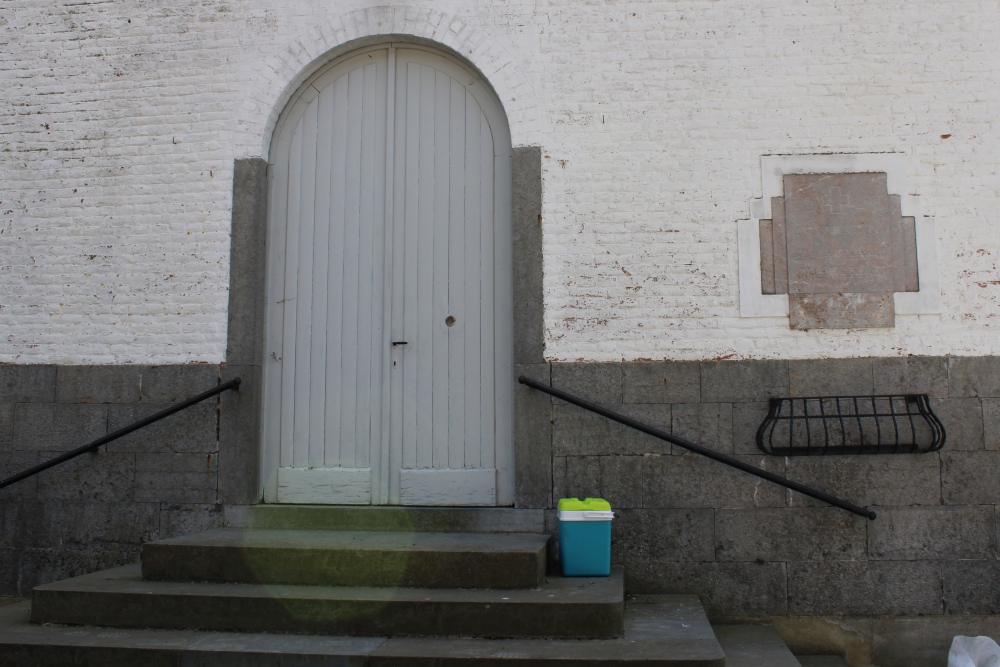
[559,498,615,577]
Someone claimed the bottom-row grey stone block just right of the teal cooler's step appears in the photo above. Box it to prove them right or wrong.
[625,561,787,619]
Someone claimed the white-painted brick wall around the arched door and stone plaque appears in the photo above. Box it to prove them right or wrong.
[0,0,1000,363]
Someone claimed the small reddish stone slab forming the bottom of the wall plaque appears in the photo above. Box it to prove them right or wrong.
[788,292,896,331]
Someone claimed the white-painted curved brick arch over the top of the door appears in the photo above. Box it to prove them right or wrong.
[237,5,539,159]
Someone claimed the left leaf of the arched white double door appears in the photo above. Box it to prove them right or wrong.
[265,52,387,503]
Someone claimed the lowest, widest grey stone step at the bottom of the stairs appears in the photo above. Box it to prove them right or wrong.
[0,595,724,667]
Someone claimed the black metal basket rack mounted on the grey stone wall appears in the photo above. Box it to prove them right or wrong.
[757,394,945,456]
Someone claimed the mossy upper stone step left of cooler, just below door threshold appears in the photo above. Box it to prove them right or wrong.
[142,528,548,589]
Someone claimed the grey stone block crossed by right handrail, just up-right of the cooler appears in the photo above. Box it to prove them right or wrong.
[642,456,785,508]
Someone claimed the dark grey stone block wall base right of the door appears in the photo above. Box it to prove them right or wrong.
[517,357,1000,619]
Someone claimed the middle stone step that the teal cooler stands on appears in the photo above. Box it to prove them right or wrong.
[32,564,625,639]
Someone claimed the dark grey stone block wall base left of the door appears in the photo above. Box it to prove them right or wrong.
[0,364,256,596]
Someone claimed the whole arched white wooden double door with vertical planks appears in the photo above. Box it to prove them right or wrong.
[263,46,513,505]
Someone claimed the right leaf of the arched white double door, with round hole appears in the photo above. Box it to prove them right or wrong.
[390,49,496,505]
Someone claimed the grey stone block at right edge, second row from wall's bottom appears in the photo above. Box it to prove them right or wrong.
[868,505,997,560]
